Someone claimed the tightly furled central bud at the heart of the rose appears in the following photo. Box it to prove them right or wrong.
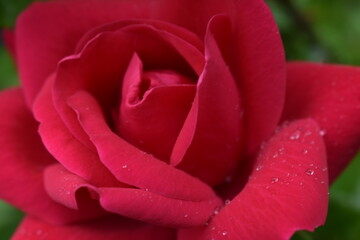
[117,54,196,161]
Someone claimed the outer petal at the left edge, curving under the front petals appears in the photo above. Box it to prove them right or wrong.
[0,89,104,223]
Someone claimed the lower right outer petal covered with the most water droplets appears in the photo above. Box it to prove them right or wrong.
[179,119,328,240]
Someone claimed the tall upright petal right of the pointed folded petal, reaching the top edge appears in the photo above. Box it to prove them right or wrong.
[221,0,286,153]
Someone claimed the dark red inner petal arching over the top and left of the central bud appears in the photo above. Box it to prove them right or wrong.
[53,24,203,151]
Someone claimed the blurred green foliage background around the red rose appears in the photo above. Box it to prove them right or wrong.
[0,0,360,240]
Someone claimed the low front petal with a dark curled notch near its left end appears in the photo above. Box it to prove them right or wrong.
[44,164,219,227]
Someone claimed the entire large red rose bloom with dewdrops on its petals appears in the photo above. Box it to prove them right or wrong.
[0,0,360,240]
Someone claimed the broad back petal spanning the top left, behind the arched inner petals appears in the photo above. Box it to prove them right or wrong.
[16,0,224,103]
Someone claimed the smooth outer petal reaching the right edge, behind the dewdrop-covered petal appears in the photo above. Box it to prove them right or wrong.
[283,63,360,181]
